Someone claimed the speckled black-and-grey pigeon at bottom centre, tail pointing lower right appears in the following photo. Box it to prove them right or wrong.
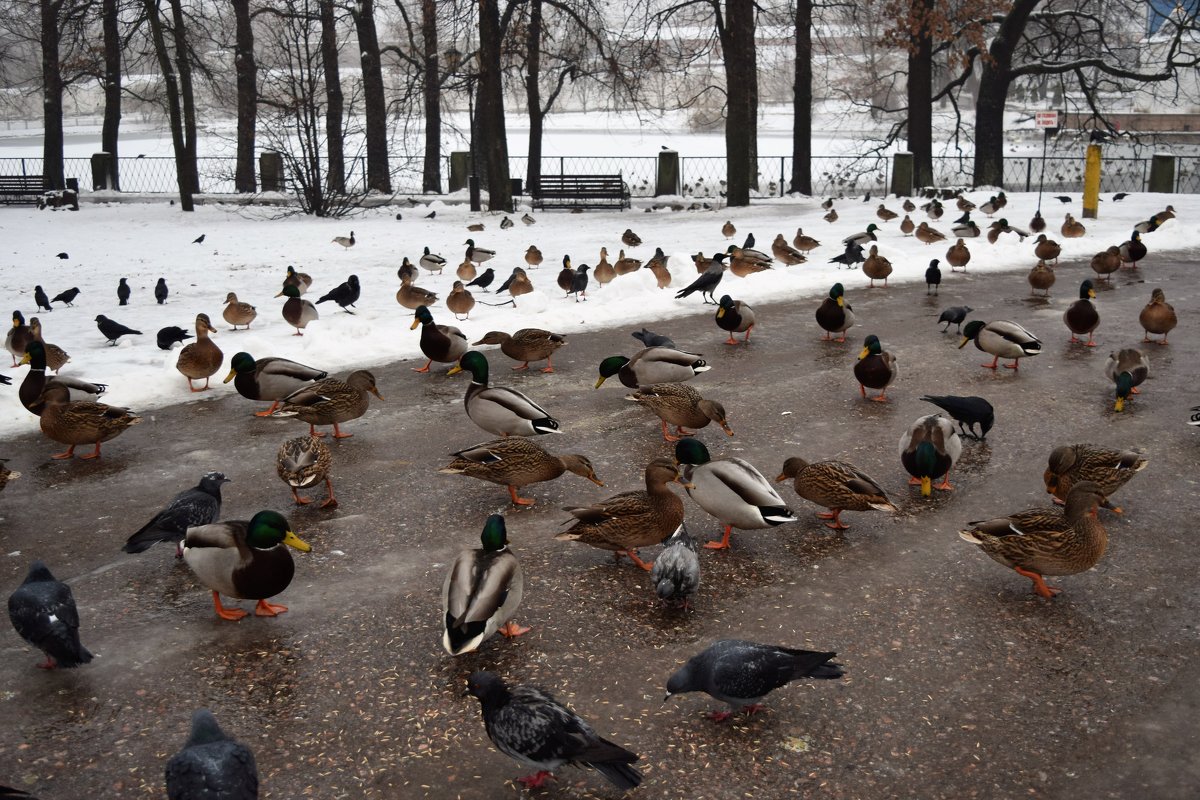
[467,670,642,790]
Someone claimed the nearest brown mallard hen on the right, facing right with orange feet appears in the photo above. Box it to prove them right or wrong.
[959,481,1109,599]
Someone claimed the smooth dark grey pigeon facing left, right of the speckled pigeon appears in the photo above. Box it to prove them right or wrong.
[662,639,846,722]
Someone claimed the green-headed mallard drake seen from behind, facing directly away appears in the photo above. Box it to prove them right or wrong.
[442,513,529,656]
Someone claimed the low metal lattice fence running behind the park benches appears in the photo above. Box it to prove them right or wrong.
[0,156,1200,199]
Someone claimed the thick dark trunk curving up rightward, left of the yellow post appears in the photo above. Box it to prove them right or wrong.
[973,0,1038,188]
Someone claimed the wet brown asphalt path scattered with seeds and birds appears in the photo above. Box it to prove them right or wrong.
[0,250,1200,800]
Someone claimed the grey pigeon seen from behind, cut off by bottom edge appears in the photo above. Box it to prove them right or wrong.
[167,709,258,800]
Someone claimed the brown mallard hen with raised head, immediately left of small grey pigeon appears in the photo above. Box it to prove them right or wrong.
[554,458,684,572]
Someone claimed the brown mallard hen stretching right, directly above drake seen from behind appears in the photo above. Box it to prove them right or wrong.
[438,437,604,506]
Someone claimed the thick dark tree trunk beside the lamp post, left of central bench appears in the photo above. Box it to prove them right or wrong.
[472,0,512,211]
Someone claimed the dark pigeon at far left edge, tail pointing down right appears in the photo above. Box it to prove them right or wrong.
[8,561,91,669]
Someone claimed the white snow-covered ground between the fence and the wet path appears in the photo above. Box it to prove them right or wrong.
[0,193,1200,434]
